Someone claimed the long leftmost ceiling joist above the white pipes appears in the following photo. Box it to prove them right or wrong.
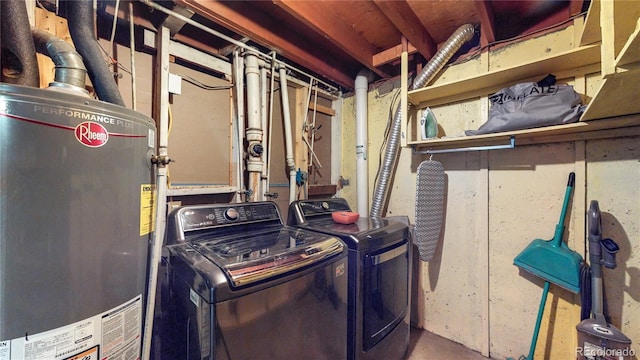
[178,0,353,88]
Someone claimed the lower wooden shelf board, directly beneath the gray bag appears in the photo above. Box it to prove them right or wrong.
[408,114,640,152]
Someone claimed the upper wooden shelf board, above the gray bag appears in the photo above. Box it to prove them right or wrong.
[407,44,600,107]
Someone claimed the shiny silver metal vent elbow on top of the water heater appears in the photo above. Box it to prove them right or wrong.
[31,28,89,96]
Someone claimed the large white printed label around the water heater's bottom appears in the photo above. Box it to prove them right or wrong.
[0,295,142,360]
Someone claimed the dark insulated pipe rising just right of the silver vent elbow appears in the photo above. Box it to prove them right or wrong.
[66,0,124,106]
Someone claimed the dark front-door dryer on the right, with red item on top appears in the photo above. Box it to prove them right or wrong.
[287,198,411,359]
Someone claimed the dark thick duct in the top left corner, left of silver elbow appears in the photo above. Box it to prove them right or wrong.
[0,0,40,87]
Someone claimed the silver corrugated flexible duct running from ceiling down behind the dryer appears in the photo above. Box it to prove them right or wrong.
[370,24,475,218]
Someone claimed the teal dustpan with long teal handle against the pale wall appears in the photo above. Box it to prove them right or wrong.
[513,172,583,360]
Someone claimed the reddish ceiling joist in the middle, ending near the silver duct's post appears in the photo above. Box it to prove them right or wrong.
[273,0,389,78]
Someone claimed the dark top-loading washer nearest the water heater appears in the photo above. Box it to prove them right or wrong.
[160,202,349,360]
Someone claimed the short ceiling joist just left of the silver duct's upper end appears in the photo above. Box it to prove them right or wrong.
[373,0,438,60]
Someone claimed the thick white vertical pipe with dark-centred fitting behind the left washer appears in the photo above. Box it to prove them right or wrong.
[244,51,264,201]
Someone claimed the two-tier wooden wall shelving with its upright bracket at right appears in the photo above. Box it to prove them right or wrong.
[405,4,640,152]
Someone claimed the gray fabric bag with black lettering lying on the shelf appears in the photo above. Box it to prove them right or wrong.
[465,82,584,135]
